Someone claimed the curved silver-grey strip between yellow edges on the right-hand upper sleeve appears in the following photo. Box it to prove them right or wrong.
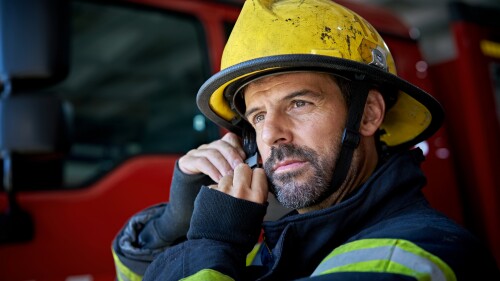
[312,243,447,281]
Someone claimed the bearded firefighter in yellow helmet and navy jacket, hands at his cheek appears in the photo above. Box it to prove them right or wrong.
[113,0,500,280]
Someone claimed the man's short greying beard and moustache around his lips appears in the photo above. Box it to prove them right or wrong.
[264,144,335,209]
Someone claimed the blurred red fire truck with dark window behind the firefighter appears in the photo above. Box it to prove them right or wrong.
[0,0,500,281]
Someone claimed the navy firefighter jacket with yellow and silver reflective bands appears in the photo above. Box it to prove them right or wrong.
[113,149,500,280]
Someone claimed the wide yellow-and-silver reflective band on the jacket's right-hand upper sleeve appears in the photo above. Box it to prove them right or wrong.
[312,239,456,281]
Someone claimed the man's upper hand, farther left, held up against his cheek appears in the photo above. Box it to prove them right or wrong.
[179,133,245,183]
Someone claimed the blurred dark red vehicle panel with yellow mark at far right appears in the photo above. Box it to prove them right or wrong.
[426,2,500,264]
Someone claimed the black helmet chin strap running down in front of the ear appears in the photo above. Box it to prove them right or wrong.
[323,74,370,199]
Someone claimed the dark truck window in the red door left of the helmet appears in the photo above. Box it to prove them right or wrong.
[51,1,219,188]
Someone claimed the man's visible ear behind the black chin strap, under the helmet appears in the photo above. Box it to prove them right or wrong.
[359,89,385,137]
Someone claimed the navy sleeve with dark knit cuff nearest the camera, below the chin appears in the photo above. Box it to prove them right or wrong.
[144,187,267,280]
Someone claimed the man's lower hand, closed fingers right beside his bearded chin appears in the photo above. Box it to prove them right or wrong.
[210,163,268,204]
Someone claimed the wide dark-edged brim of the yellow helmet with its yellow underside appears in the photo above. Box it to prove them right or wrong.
[196,54,444,151]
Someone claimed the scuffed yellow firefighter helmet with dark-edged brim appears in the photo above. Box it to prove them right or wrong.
[197,0,444,150]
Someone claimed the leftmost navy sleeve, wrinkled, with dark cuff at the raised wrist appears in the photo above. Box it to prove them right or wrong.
[112,160,212,280]
